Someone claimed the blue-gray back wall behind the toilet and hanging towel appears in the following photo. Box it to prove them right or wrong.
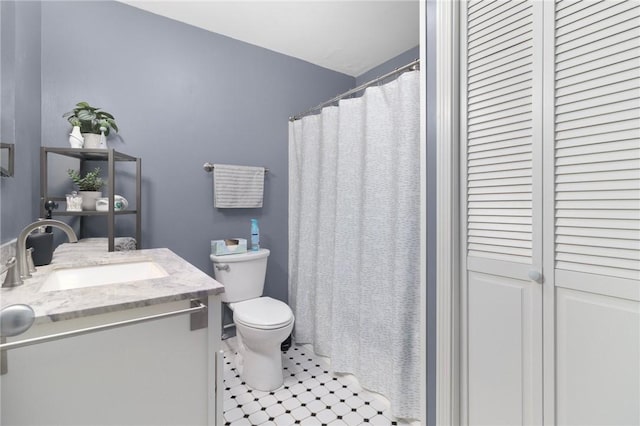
[42,2,355,300]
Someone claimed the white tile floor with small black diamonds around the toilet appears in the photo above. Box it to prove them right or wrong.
[224,339,417,426]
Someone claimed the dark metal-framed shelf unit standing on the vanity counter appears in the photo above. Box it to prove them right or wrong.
[40,146,142,251]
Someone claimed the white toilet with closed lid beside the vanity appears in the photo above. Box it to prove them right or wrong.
[210,249,294,391]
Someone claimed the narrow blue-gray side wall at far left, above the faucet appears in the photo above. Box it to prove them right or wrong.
[0,1,40,243]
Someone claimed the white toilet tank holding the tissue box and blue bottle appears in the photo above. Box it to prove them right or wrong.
[209,248,269,303]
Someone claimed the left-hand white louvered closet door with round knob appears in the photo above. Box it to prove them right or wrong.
[461,1,542,426]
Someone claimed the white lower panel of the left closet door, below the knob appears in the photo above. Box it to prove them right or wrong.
[468,272,537,426]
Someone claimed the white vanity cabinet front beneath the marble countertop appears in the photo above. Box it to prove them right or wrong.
[0,295,224,426]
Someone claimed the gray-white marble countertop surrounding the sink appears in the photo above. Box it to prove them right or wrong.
[0,239,224,323]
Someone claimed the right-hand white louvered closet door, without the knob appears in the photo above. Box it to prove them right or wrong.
[545,0,640,425]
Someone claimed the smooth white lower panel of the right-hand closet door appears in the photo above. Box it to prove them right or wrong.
[556,286,640,426]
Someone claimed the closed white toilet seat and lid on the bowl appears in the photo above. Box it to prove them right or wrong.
[229,297,293,330]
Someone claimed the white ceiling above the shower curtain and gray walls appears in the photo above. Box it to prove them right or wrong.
[122,0,420,77]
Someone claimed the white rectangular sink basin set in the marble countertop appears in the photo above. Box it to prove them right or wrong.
[40,260,169,291]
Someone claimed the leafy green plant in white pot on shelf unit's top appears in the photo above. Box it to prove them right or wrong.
[62,102,118,149]
